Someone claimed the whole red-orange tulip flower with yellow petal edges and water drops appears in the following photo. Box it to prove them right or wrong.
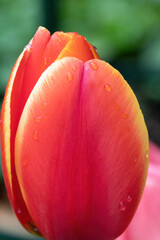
[1,27,148,240]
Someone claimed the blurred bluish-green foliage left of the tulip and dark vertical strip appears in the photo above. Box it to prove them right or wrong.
[0,0,43,96]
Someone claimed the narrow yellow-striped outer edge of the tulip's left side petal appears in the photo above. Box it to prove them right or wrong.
[1,49,39,235]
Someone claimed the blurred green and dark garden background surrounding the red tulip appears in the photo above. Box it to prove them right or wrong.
[0,0,160,240]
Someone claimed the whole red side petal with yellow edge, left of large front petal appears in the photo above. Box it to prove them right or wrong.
[1,27,54,235]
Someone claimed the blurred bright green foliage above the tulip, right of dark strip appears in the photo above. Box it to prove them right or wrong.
[60,0,160,60]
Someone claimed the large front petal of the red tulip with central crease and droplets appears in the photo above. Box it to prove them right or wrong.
[15,58,148,240]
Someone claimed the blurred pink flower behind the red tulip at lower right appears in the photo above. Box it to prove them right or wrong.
[117,142,160,240]
